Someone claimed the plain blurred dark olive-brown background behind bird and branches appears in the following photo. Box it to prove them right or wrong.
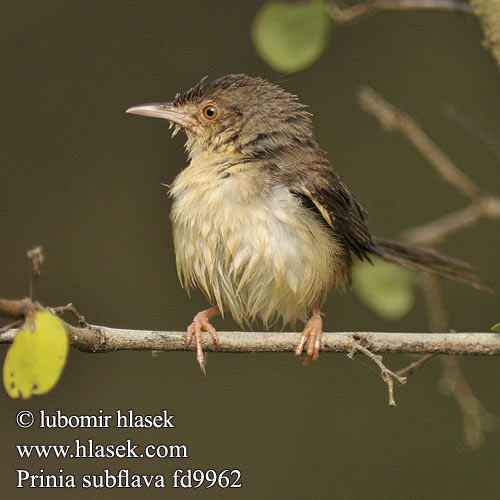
[0,0,500,499]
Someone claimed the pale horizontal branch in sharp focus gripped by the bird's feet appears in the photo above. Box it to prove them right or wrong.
[0,322,500,355]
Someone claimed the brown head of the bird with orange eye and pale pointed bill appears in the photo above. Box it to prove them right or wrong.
[127,74,314,157]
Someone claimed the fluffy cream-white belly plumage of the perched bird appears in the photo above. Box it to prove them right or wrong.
[172,182,345,325]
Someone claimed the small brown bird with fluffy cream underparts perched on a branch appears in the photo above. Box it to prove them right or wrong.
[127,74,482,372]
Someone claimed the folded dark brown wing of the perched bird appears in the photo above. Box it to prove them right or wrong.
[280,152,379,260]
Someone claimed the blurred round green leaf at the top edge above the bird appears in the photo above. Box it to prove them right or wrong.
[252,1,331,73]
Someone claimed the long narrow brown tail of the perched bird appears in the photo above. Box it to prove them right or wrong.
[373,236,493,293]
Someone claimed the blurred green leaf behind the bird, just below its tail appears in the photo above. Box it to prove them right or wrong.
[353,259,415,320]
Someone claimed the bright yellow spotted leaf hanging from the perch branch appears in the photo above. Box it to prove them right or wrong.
[3,311,69,399]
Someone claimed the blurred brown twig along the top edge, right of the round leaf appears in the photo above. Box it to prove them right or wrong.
[328,0,473,23]
